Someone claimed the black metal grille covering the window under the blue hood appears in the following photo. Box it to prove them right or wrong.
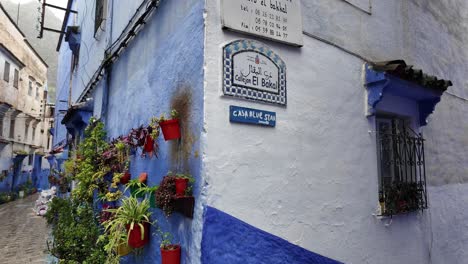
[377,119,427,216]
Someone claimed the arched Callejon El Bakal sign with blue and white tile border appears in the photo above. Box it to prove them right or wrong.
[223,40,287,106]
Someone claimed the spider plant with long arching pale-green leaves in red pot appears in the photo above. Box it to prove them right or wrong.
[104,197,152,248]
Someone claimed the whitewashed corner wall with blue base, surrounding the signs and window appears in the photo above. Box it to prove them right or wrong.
[202,0,468,263]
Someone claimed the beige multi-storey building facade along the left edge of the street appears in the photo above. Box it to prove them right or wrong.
[0,5,53,189]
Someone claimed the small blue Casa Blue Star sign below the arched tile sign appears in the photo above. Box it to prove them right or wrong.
[229,105,276,127]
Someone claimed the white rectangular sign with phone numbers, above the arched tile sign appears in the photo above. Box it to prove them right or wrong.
[221,0,302,46]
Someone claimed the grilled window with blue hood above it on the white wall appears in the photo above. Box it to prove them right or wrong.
[366,60,452,216]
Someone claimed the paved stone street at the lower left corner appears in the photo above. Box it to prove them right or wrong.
[0,194,48,264]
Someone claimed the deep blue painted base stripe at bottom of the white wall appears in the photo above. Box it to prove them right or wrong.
[201,206,341,264]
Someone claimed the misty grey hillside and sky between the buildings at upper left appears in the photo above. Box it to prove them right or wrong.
[0,0,65,102]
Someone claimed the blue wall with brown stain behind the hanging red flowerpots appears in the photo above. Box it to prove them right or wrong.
[105,0,204,263]
